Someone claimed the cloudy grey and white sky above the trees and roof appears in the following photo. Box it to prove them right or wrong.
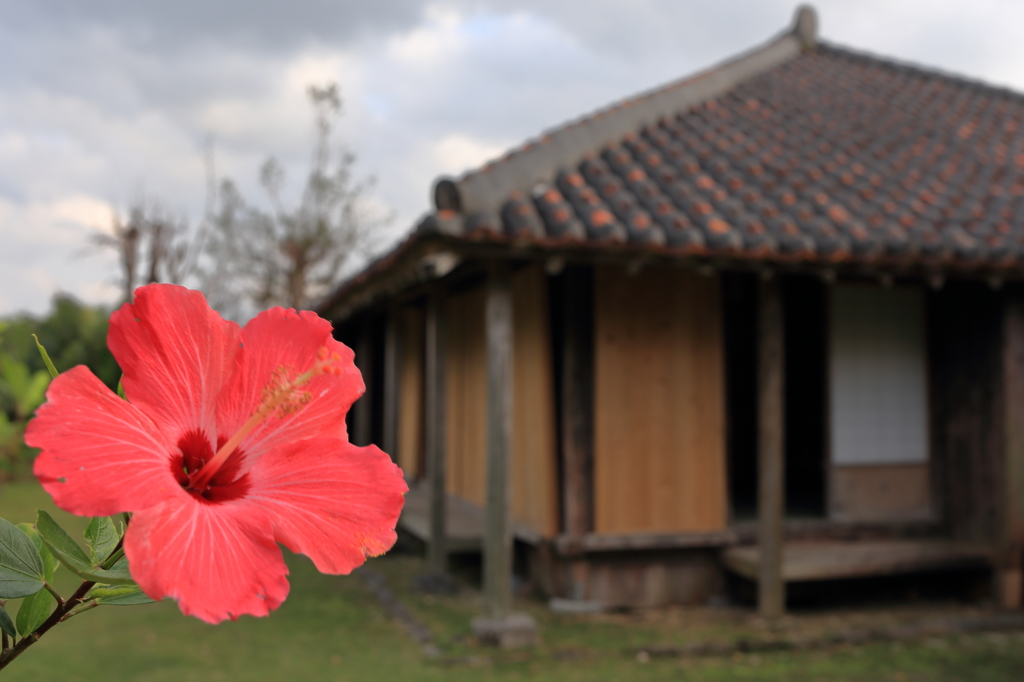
[0,0,1024,315]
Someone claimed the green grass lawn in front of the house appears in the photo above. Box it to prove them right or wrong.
[0,483,1024,682]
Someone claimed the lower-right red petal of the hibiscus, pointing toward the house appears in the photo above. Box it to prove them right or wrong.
[246,438,409,573]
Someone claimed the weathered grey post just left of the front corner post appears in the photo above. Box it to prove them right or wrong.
[423,291,447,573]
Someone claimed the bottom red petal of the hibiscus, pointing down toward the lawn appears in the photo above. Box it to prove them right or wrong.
[125,492,289,624]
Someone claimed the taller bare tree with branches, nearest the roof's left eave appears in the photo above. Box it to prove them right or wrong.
[203,83,388,316]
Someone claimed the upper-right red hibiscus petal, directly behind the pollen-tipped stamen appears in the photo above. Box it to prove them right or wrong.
[217,307,364,458]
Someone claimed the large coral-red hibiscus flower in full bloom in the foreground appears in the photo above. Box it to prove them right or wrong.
[26,285,407,623]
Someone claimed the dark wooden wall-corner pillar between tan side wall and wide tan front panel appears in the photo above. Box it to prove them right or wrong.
[559,266,594,599]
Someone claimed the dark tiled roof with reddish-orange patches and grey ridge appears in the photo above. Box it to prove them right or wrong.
[315,8,1024,315]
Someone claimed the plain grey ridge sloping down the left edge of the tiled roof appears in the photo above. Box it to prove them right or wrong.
[434,5,817,214]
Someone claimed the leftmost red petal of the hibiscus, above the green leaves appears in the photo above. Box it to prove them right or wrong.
[25,366,180,516]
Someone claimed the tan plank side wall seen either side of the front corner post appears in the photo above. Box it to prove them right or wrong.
[444,265,558,537]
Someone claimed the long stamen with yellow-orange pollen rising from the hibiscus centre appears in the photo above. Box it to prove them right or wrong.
[188,346,342,491]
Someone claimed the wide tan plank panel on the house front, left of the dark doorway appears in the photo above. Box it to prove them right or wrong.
[594,266,727,534]
